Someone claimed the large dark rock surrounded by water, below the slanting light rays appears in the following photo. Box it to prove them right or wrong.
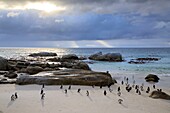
[89,52,123,62]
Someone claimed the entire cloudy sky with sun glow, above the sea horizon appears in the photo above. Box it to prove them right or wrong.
[0,0,170,48]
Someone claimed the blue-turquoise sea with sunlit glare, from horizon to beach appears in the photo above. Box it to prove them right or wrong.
[0,48,170,88]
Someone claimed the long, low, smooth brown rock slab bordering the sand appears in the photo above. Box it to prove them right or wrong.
[16,69,114,86]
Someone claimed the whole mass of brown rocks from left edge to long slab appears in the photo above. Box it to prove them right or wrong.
[0,52,114,85]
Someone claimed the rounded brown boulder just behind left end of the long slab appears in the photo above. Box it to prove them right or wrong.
[26,66,43,74]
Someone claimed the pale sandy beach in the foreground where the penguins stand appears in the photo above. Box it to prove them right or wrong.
[0,84,170,113]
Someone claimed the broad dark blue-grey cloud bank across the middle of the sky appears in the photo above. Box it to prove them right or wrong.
[0,11,170,41]
